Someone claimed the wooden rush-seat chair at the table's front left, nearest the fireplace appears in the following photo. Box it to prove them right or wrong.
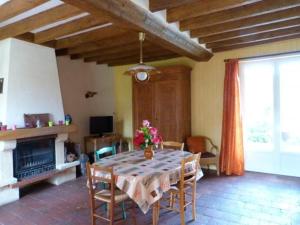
[86,163,136,225]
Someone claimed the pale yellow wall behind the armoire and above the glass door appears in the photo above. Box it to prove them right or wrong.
[114,39,300,149]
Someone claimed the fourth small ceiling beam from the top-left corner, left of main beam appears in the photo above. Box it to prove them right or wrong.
[55,25,125,49]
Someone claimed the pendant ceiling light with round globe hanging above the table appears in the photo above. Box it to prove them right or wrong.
[124,32,160,82]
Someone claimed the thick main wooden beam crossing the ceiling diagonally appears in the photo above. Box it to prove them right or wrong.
[60,0,212,61]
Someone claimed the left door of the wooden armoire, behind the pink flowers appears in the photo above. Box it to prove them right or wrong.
[133,81,154,132]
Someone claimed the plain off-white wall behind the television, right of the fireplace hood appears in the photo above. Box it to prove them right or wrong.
[57,57,114,147]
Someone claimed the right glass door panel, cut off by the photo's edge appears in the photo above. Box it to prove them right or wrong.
[278,58,300,176]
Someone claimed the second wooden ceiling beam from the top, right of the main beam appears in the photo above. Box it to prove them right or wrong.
[167,0,262,23]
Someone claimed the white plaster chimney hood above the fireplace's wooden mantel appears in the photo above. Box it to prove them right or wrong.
[2,39,64,128]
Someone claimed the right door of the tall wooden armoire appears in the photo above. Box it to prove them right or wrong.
[154,80,180,141]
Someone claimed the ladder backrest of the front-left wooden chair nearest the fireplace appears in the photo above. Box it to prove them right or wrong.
[86,162,115,202]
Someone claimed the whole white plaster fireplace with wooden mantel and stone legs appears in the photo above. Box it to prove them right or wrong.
[0,39,79,205]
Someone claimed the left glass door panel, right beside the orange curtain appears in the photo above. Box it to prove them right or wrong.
[240,61,279,173]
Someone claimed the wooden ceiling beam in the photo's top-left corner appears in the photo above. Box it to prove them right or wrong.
[0,0,48,21]
